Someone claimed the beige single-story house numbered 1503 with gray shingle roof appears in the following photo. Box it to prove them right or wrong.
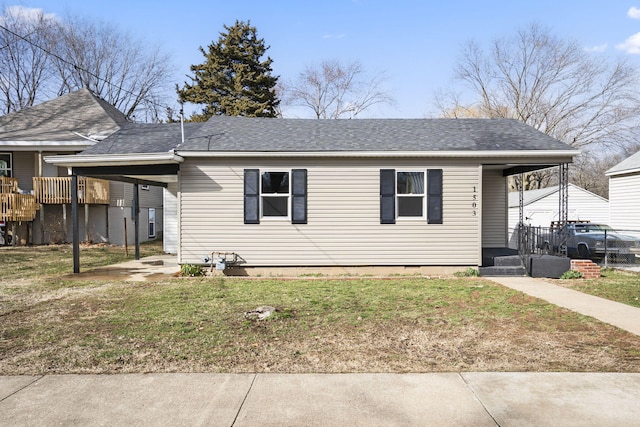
[48,117,578,274]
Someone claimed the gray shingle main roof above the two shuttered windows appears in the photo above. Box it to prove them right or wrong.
[177,116,573,152]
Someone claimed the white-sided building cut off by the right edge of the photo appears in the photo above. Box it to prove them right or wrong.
[606,152,640,232]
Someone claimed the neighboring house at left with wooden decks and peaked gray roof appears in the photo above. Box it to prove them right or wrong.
[0,89,162,244]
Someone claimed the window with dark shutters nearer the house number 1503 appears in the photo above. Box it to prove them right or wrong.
[380,169,442,224]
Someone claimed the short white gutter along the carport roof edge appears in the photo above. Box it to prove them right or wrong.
[44,152,184,167]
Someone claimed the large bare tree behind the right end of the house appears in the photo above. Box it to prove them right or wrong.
[438,24,640,189]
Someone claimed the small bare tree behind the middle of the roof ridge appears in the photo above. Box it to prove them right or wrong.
[285,60,393,119]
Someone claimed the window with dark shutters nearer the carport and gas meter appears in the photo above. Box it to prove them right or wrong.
[244,169,307,224]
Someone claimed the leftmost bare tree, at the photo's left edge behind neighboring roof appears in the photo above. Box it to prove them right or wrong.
[0,6,57,114]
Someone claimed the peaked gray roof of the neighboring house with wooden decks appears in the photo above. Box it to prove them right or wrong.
[0,89,128,144]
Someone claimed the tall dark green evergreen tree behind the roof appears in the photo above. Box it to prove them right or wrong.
[176,21,280,121]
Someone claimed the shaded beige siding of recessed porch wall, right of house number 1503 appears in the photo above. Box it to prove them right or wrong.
[482,169,507,248]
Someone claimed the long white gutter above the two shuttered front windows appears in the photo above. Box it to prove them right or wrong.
[176,150,580,159]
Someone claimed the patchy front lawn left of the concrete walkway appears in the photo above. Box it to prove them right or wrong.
[0,247,640,375]
